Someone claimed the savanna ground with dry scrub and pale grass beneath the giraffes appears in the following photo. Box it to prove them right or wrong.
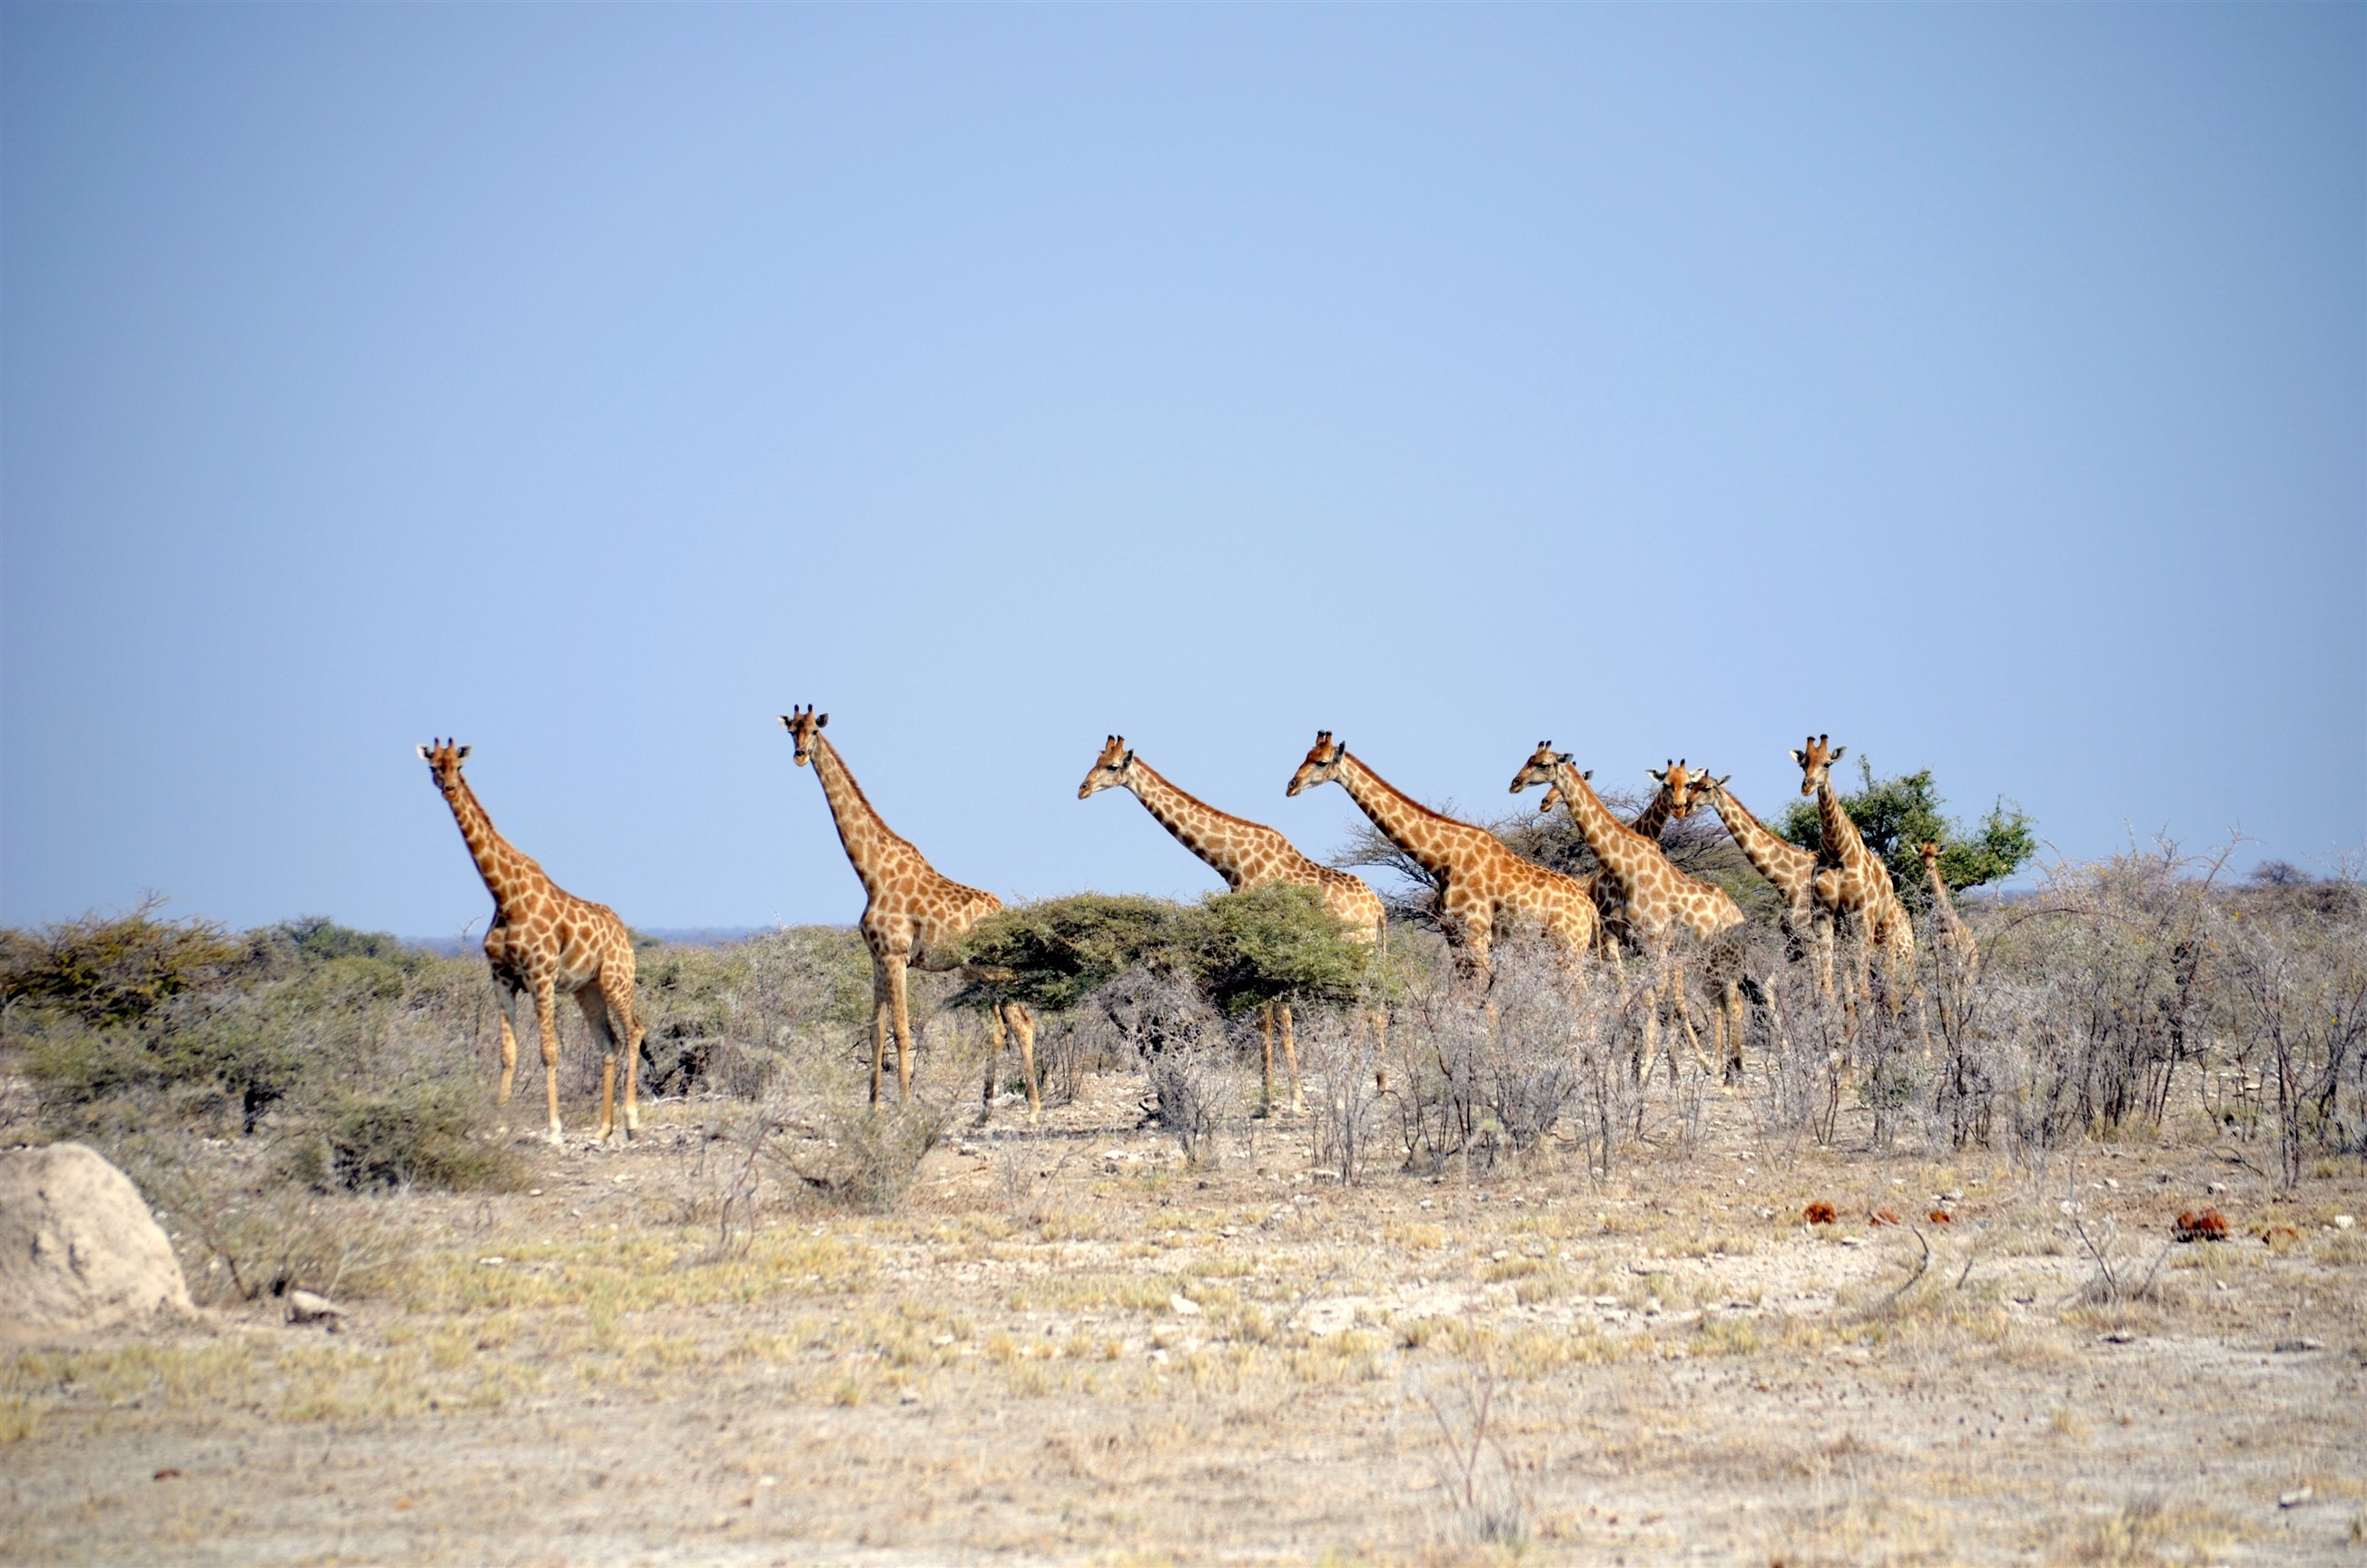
[0,860,2367,1565]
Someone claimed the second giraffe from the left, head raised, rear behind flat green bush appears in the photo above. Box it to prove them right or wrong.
[781,704,1044,1116]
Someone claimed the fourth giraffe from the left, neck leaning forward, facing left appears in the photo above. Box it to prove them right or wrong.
[1283,729,1600,981]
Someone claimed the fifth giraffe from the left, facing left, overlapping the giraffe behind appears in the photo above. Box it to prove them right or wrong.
[1513,742,1742,1082]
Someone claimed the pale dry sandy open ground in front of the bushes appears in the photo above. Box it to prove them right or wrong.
[0,1078,2367,1565]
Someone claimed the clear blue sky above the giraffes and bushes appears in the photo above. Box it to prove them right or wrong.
[0,5,2367,935]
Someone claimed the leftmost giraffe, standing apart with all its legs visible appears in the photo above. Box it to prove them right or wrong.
[419,742,641,1147]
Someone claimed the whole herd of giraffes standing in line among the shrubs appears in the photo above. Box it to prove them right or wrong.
[419,705,1978,1144]
